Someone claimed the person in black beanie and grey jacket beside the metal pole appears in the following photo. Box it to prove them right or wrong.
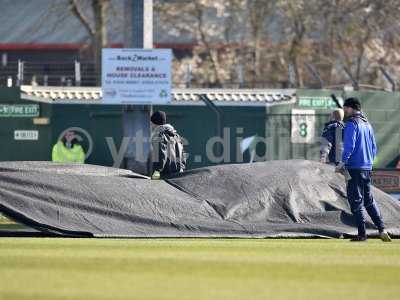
[150,111,186,179]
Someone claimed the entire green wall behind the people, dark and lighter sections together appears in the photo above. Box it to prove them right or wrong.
[0,88,400,168]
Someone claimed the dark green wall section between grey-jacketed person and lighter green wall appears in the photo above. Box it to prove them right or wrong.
[153,106,265,168]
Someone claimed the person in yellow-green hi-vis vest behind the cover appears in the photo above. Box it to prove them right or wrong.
[52,130,85,164]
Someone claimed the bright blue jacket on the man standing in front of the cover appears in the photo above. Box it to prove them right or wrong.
[342,112,377,170]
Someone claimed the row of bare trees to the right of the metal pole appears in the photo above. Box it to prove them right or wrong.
[152,0,400,87]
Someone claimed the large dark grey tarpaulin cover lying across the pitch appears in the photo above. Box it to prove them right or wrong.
[0,160,400,237]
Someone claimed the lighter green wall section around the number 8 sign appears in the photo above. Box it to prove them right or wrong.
[266,90,400,168]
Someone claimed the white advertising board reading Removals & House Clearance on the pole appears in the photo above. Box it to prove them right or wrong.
[102,48,172,104]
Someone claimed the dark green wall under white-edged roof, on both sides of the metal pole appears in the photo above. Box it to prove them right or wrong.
[51,105,265,168]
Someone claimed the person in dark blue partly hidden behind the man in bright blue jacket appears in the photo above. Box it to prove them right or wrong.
[320,108,344,164]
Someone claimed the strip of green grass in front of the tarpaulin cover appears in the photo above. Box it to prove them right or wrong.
[0,238,400,300]
